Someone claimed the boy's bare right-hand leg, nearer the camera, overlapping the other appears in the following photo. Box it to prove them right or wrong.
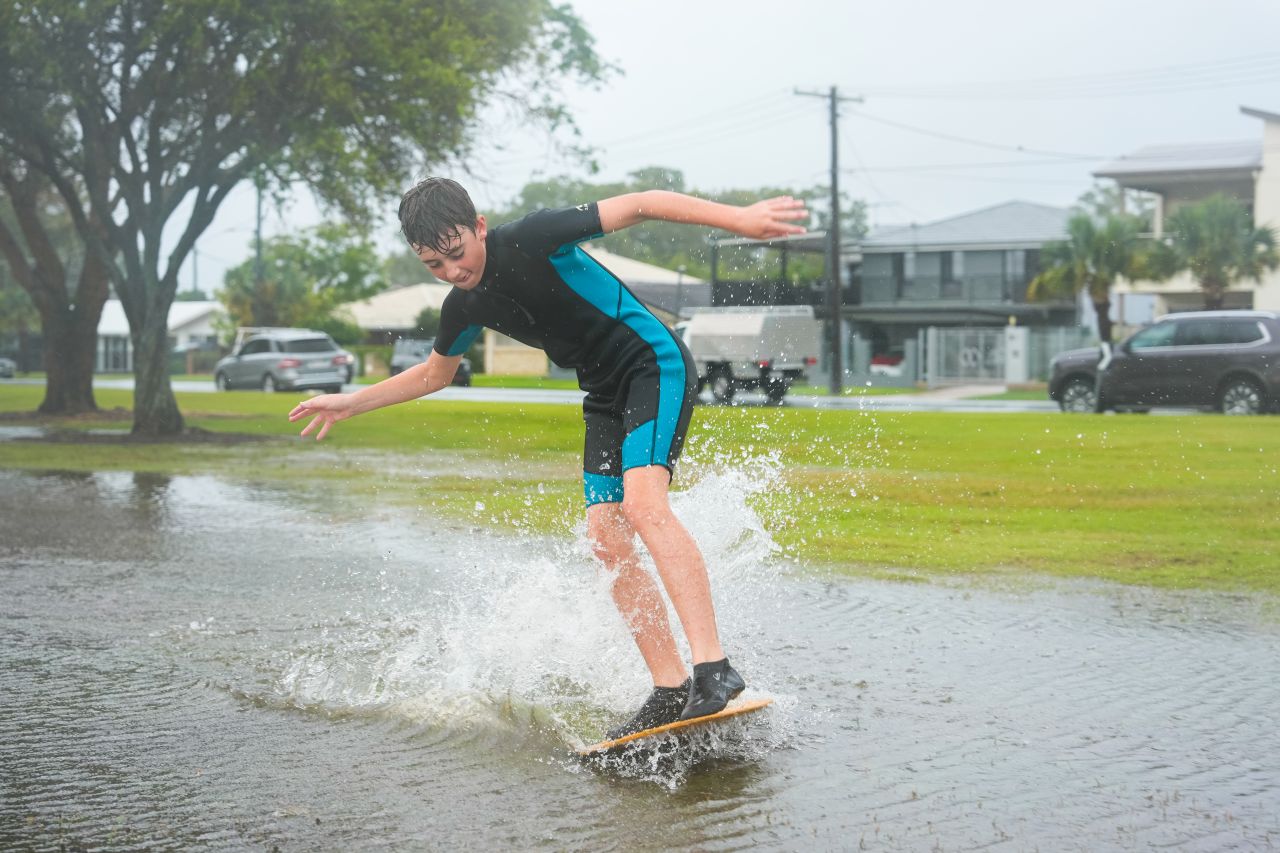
[622,465,724,663]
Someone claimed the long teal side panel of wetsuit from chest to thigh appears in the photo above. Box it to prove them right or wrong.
[550,243,685,471]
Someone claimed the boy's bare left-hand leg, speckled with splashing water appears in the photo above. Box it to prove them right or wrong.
[586,503,689,686]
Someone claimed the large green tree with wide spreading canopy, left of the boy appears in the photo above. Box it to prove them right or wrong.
[0,0,603,434]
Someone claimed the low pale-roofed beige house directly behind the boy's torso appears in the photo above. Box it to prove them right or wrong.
[346,243,710,377]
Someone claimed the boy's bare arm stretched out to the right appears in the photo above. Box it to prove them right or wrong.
[596,190,809,240]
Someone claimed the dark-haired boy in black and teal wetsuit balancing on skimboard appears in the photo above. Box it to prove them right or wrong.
[289,178,808,739]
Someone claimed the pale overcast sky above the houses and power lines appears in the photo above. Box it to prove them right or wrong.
[180,0,1280,292]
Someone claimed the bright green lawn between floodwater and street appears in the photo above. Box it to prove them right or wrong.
[0,386,1280,592]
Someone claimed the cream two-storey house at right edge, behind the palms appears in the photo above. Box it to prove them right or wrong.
[1093,106,1280,314]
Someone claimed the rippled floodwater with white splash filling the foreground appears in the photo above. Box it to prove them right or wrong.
[0,471,1280,850]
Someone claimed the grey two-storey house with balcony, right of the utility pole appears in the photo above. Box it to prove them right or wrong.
[844,201,1079,359]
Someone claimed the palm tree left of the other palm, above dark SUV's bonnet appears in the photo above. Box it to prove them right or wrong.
[1027,213,1143,342]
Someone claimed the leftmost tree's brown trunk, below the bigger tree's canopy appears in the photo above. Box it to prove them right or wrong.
[0,161,109,415]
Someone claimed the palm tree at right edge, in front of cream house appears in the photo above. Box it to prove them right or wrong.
[1152,193,1280,310]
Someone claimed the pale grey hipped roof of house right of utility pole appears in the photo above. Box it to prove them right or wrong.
[863,201,1071,254]
